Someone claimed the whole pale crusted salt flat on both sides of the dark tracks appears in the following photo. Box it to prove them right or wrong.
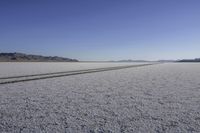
[0,63,200,133]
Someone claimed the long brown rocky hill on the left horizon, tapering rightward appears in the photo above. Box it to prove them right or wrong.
[0,53,78,62]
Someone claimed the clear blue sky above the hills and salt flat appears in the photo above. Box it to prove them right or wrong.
[0,0,200,60]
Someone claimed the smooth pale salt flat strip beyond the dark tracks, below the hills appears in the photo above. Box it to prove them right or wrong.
[0,62,148,78]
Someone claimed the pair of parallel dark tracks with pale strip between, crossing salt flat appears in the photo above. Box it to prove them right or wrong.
[0,63,158,84]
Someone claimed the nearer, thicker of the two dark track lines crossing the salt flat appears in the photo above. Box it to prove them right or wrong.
[0,63,160,85]
